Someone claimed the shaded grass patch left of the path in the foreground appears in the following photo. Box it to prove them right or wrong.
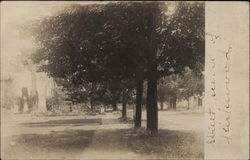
[3,130,95,159]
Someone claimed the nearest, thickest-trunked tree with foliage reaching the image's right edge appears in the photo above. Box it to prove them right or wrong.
[144,2,205,134]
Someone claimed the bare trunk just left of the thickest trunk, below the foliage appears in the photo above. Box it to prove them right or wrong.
[135,78,143,128]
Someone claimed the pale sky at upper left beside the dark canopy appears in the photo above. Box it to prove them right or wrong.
[1,1,104,76]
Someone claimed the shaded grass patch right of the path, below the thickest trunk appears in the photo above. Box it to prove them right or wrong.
[129,130,204,159]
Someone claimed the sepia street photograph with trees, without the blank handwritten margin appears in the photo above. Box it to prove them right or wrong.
[1,1,247,160]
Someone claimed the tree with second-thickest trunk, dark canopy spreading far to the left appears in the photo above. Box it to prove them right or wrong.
[26,3,148,127]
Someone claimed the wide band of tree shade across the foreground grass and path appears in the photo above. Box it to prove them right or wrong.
[4,129,204,159]
